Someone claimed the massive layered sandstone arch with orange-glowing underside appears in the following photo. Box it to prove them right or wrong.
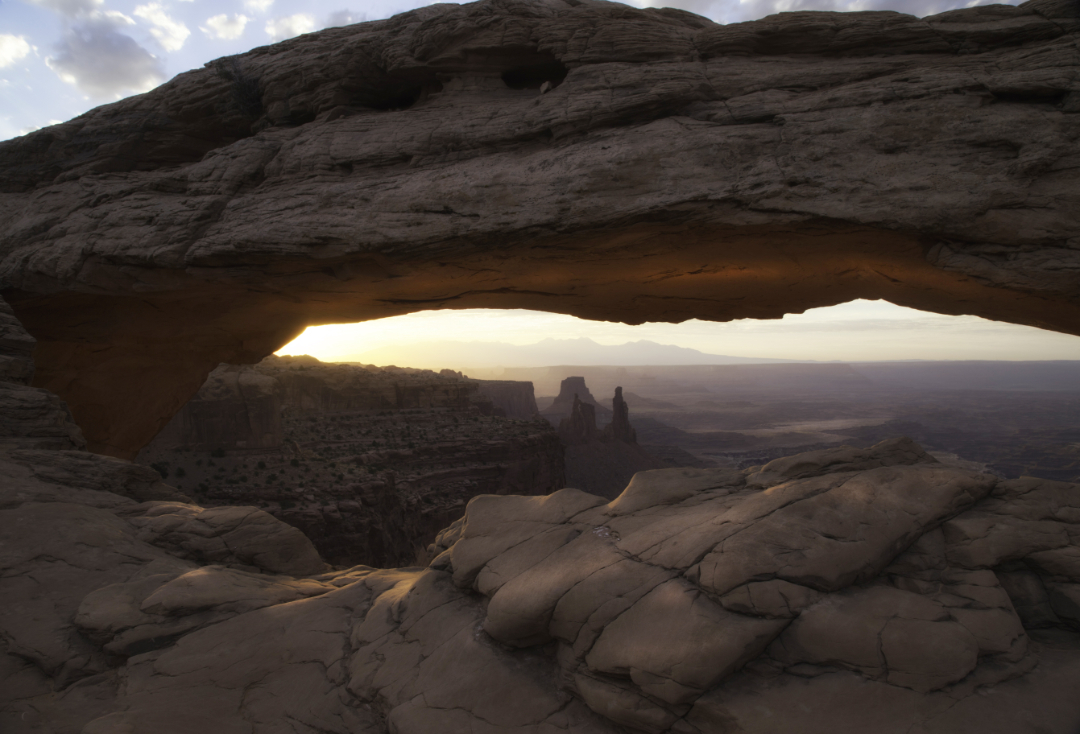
[0,0,1080,457]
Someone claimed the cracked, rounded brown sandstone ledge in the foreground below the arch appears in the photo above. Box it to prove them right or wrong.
[0,295,1080,734]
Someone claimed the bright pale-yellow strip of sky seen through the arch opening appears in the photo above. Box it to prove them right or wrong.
[278,300,1080,367]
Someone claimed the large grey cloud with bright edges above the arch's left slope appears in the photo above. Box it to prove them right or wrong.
[45,11,165,99]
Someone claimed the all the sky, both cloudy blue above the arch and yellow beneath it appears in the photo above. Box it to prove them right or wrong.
[6,0,1080,361]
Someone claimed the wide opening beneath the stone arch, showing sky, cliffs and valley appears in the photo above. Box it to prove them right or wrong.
[137,301,1080,567]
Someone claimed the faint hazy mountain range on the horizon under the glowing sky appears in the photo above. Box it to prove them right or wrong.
[341,337,805,369]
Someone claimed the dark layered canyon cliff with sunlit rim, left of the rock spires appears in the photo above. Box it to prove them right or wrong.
[136,356,566,568]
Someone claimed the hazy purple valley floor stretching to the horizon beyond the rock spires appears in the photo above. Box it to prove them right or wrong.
[518,361,1080,481]
